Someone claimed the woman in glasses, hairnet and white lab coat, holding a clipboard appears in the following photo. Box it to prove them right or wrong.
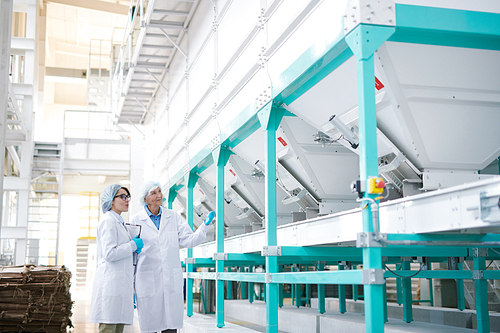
[89,184,143,333]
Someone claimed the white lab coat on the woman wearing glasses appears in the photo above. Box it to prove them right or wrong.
[89,211,137,325]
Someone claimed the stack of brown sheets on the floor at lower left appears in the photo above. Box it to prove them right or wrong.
[0,265,73,333]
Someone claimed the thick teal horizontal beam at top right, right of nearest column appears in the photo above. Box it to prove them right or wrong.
[389,4,500,50]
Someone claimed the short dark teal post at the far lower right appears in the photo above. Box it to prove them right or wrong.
[473,248,490,333]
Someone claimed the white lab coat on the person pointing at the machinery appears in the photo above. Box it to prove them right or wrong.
[131,208,209,332]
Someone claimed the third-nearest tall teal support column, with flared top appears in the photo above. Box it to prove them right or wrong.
[212,146,231,328]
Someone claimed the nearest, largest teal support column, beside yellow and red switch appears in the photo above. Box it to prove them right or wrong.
[345,24,395,333]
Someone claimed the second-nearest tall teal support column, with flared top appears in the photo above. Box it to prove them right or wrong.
[257,102,285,333]
